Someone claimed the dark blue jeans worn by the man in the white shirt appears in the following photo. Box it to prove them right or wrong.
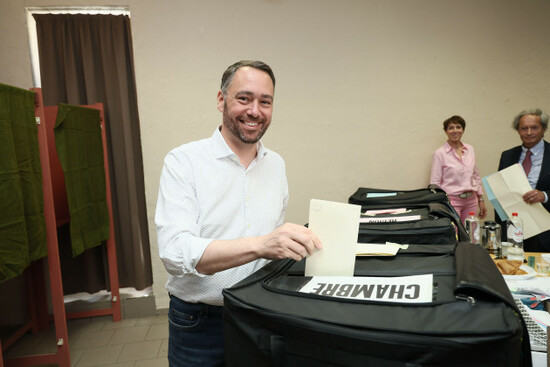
[168,295,225,367]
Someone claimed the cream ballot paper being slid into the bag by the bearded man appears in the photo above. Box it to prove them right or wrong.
[305,199,361,277]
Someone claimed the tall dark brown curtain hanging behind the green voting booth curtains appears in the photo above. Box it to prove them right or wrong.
[34,14,153,293]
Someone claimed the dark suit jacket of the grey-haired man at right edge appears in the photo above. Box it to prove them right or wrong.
[497,140,550,251]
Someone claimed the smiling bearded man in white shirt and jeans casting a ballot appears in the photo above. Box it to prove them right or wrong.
[155,60,322,367]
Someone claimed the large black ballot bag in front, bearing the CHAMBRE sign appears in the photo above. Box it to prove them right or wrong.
[223,243,531,367]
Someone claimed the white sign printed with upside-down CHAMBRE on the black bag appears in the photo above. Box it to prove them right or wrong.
[300,274,433,303]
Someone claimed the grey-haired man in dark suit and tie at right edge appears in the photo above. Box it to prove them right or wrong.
[498,108,550,252]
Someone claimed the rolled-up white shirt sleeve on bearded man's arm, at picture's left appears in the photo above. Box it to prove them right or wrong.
[155,153,213,277]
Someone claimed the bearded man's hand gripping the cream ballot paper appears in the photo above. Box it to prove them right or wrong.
[257,223,323,261]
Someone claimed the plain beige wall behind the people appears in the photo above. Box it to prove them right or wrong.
[0,0,550,307]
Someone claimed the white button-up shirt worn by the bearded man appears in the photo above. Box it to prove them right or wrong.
[155,128,288,306]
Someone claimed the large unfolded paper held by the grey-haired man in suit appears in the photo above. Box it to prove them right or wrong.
[483,163,550,238]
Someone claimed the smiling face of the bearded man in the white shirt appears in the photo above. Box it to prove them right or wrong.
[218,66,274,144]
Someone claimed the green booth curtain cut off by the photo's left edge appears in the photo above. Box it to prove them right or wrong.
[0,84,47,282]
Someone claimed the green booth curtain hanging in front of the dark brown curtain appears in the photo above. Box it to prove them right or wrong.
[54,104,110,256]
